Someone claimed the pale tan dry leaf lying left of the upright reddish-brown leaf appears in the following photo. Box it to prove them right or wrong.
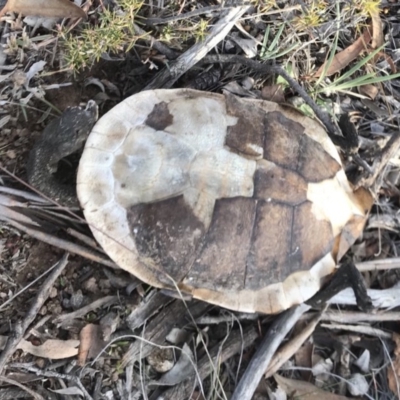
[18,339,79,360]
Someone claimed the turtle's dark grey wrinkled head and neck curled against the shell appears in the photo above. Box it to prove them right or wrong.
[26,100,98,207]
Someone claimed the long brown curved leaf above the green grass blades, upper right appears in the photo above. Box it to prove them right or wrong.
[314,27,372,78]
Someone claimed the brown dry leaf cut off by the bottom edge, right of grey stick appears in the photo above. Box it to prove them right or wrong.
[274,374,349,400]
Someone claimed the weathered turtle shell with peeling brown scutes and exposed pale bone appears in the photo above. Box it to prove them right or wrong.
[77,89,369,313]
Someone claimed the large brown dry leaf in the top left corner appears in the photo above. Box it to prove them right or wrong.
[0,0,86,18]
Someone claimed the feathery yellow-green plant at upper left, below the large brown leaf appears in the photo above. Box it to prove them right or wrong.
[61,0,143,71]
